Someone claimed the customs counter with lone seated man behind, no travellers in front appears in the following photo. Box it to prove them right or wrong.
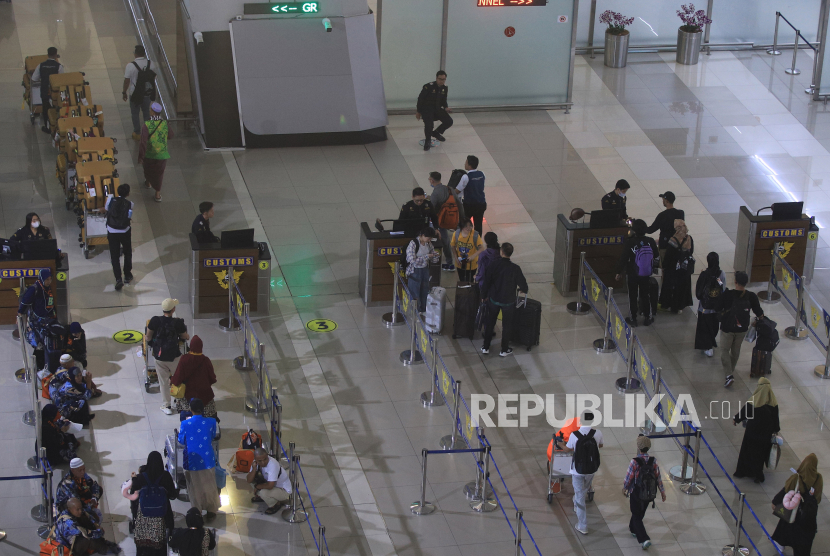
[189,233,271,319]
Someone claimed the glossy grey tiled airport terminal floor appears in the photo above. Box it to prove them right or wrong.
[0,0,830,556]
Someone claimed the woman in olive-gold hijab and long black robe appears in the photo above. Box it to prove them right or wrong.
[732,378,781,483]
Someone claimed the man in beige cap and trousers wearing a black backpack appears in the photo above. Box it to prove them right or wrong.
[147,297,190,415]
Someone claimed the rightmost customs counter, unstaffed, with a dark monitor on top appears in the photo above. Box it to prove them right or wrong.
[734,207,819,282]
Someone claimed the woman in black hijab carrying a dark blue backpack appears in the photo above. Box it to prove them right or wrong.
[130,452,179,556]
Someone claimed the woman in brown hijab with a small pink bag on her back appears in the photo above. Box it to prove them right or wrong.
[772,454,824,556]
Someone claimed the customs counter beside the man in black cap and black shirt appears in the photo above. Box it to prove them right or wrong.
[553,214,631,295]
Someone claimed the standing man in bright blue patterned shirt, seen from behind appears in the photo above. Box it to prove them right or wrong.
[179,398,220,520]
